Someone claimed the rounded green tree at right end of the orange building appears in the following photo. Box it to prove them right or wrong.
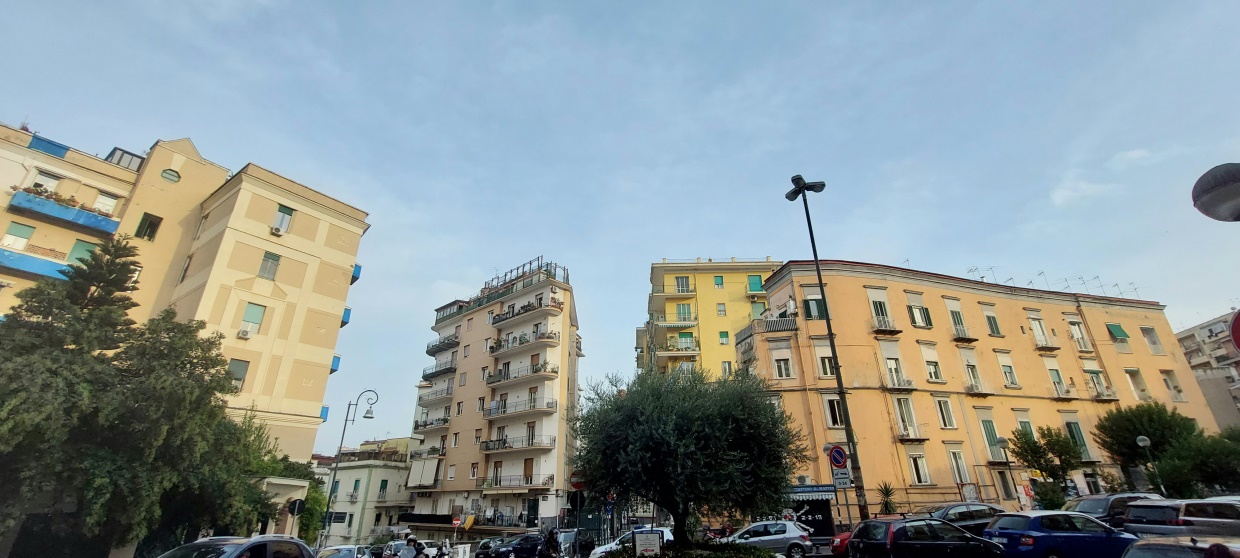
[1094,402,1204,485]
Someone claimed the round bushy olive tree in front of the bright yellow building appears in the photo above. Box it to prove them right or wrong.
[574,370,808,542]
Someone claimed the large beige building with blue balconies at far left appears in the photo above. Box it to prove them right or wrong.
[0,126,368,458]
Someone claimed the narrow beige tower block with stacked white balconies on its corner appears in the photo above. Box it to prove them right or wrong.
[401,257,584,538]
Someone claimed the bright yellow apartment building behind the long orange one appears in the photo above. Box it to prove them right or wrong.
[635,257,780,374]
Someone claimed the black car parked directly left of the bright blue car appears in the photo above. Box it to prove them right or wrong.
[848,517,1003,558]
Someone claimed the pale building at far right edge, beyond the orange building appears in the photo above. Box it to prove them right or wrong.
[1176,309,1240,428]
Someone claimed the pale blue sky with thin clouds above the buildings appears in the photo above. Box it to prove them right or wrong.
[0,0,1240,453]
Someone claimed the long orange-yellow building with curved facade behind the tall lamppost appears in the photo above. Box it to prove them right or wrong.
[735,260,1218,517]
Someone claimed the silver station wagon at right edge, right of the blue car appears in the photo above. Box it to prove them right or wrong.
[1123,500,1240,537]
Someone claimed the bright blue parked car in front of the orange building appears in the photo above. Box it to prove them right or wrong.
[982,510,1137,558]
